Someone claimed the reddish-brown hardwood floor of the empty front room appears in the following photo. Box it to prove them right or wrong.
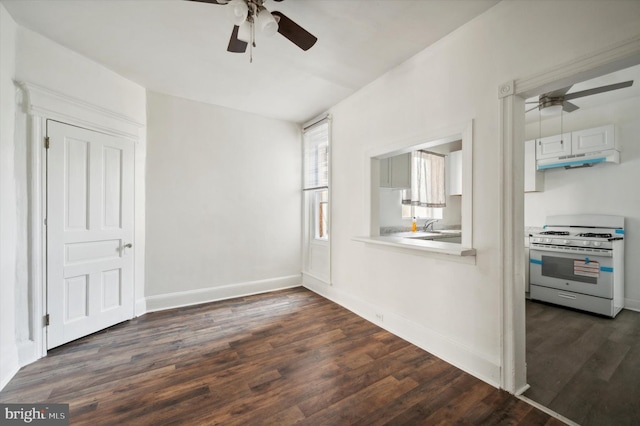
[0,288,562,425]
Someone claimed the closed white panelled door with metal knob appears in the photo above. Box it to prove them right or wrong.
[47,121,134,348]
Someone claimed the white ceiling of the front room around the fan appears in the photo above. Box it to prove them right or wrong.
[2,0,498,122]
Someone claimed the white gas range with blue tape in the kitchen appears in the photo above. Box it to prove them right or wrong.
[529,215,624,318]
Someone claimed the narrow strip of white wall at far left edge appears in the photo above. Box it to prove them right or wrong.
[0,3,19,389]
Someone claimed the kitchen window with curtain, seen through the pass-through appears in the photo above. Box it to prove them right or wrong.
[402,150,447,219]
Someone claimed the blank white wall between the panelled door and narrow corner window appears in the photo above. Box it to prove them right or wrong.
[146,92,301,309]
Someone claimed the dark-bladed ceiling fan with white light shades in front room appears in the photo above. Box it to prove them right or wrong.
[188,0,318,57]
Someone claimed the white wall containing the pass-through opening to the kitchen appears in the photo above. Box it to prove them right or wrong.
[306,1,640,386]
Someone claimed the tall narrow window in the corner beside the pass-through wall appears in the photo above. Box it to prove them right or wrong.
[302,119,329,240]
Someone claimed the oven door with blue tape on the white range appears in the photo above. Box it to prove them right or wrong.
[529,247,613,299]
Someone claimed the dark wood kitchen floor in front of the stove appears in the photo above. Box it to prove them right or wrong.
[524,300,640,426]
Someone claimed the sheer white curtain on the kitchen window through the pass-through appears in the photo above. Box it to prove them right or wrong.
[402,151,447,207]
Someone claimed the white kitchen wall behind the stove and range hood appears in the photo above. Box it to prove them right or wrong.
[525,95,640,310]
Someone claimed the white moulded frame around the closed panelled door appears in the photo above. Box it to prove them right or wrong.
[15,81,146,365]
